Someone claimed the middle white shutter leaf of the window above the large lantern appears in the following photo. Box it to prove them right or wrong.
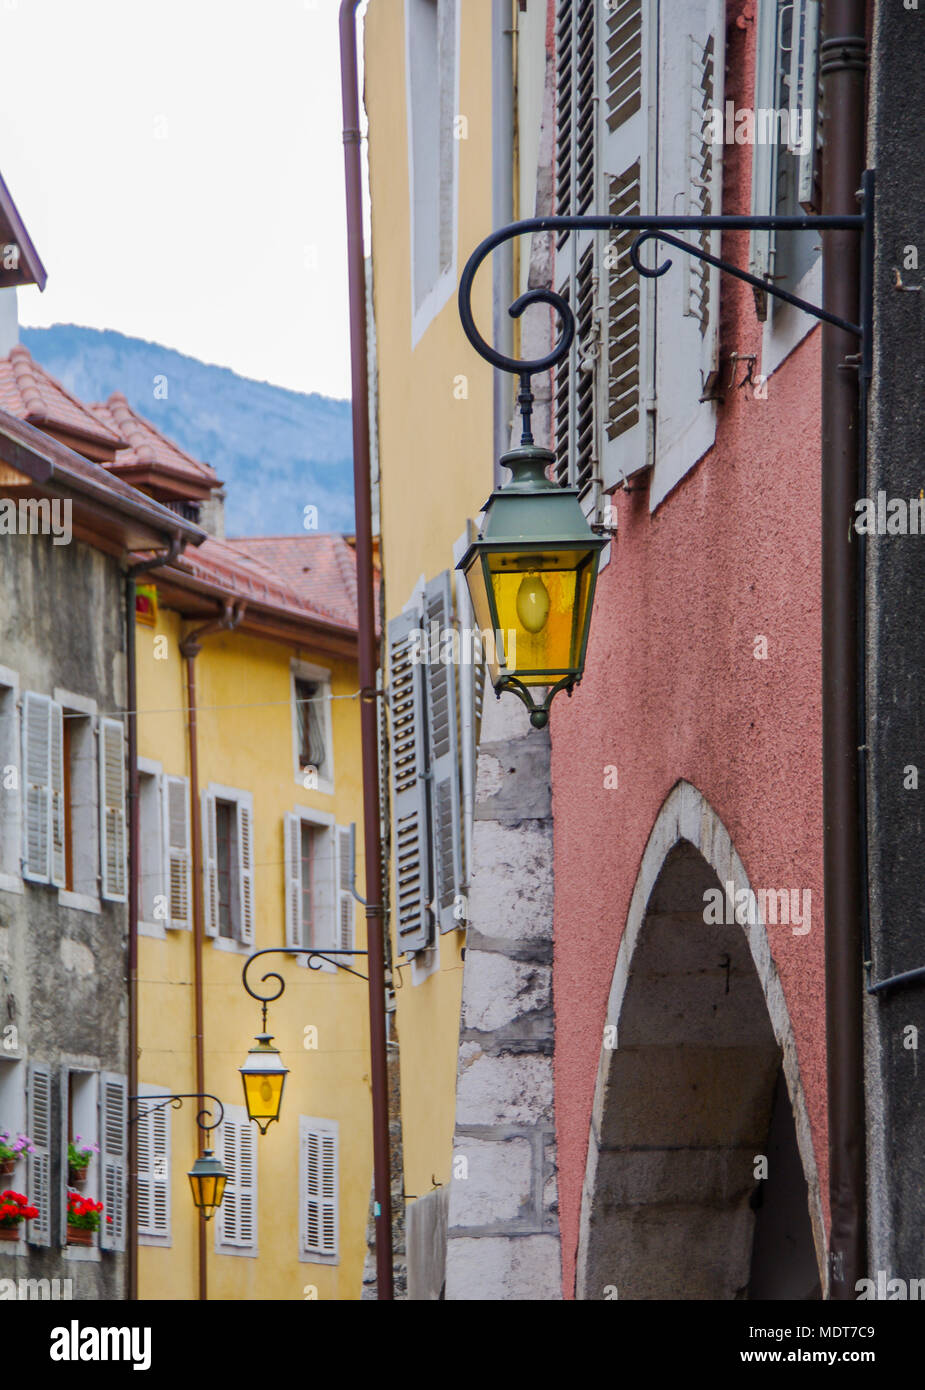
[597,0,658,491]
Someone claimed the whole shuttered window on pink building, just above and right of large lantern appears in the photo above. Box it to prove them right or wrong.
[555,0,725,516]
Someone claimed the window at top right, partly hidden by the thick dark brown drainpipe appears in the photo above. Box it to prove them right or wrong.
[750,0,822,375]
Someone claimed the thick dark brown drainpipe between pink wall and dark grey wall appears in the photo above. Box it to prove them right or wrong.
[821,0,867,1300]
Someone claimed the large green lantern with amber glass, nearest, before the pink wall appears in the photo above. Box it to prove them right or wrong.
[456,443,606,728]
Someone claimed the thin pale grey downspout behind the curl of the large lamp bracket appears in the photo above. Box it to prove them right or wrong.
[491,0,511,488]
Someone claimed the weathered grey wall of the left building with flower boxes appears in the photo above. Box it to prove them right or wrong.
[0,535,128,1298]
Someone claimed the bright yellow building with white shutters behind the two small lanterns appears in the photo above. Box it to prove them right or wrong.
[136,537,371,1301]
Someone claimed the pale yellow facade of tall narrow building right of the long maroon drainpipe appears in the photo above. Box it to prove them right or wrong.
[364,0,492,1212]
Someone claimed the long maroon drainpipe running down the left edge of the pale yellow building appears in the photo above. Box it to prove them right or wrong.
[339,0,394,1300]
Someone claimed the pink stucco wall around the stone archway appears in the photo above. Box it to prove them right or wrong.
[551,3,828,1297]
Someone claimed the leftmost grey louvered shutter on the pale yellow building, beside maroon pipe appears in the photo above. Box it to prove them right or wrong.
[388,612,433,952]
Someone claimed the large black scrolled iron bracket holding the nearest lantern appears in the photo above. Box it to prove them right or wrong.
[459,170,874,445]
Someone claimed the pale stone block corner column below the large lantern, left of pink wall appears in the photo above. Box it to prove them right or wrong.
[445,696,562,1300]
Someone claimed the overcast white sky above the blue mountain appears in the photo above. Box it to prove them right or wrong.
[0,0,358,396]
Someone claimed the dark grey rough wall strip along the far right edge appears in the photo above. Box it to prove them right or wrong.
[867,0,925,1280]
